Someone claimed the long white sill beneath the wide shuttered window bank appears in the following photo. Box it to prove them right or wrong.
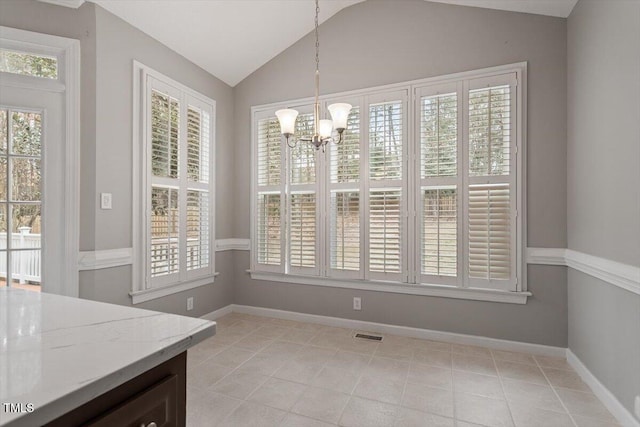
[249,271,533,304]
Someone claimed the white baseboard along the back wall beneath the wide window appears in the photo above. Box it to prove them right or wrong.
[230,304,566,357]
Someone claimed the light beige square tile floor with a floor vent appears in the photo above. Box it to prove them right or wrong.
[187,313,617,427]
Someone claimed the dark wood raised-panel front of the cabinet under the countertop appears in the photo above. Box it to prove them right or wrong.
[85,375,178,427]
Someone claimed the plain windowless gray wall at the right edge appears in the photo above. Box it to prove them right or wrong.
[567,0,640,418]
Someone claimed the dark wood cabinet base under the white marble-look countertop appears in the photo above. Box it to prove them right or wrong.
[46,352,187,427]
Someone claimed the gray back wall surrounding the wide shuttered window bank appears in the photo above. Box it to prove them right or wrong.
[234,0,567,346]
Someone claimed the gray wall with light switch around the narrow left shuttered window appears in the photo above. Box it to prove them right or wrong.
[80,6,233,316]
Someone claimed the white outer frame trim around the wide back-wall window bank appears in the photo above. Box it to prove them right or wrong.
[249,62,532,304]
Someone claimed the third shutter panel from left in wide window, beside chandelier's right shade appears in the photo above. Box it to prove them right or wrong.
[327,101,364,278]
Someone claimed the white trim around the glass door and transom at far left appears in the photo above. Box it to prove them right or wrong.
[0,26,80,298]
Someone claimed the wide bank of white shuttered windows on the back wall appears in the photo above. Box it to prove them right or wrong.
[251,64,528,302]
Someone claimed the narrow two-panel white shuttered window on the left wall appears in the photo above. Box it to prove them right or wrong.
[133,64,215,302]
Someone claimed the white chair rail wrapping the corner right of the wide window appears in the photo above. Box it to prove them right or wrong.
[527,248,640,295]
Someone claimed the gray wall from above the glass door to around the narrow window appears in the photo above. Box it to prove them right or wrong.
[0,0,234,316]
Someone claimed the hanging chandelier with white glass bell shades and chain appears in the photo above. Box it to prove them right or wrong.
[276,0,351,152]
